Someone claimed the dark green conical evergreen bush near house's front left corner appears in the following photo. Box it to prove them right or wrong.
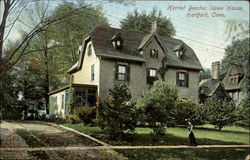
[99,83,136,140]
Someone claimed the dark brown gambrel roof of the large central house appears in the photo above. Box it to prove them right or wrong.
[68,25,203,73]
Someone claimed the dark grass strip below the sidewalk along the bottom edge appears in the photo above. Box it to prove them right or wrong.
[116,148,249,160]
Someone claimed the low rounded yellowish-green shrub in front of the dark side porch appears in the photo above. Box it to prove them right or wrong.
[74,106,96,124]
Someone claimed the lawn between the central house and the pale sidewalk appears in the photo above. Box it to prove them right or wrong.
[65,124,250,145]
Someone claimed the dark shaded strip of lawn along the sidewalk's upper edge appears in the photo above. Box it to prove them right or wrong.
[93,134,242,146]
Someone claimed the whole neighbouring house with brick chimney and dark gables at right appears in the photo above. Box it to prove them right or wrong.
[199,61,247,104]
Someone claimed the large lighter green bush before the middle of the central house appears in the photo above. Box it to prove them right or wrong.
[137,80,178,136]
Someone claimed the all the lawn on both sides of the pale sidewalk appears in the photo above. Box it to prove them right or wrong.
[64,124,250,160]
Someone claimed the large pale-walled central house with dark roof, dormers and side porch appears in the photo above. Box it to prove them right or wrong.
[50,22,202,116]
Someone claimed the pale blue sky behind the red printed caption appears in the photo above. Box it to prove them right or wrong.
[0,1,249,68]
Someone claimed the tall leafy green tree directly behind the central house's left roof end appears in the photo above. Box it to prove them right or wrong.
[49,2,109,67]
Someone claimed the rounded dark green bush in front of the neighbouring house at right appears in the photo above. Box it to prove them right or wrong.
[202,96,236,130]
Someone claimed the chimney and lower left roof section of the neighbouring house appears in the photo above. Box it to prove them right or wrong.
[199,61,231,103]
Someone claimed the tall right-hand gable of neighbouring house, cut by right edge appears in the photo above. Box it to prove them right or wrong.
[222,62,249,104]
